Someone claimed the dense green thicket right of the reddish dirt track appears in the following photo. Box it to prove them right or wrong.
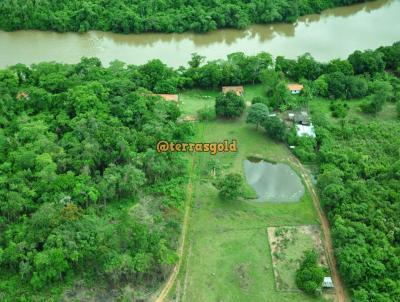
[317,114,400,302]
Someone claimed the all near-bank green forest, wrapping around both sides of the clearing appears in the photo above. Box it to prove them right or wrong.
[0,42,400,302]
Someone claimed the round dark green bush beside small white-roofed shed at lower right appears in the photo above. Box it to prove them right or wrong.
[296,250,324,295]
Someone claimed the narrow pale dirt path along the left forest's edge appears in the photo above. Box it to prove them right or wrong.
[154,155,195,302]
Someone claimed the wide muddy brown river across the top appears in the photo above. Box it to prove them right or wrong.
[0,0,400,67]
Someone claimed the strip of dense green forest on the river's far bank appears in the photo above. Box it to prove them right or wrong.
[0,0,365,33]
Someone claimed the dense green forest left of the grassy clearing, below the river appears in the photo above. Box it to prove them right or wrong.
[0,59,191,301]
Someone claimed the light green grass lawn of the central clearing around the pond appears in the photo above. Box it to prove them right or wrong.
[171,86,326,302]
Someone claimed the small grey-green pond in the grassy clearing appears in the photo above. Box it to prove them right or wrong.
[244,158,304,203]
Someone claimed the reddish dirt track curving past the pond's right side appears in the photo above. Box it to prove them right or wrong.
[291,156,347,302]
